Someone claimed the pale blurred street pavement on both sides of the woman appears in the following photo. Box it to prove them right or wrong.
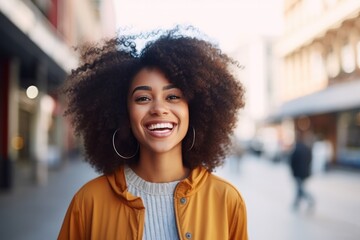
[0,156,360,240]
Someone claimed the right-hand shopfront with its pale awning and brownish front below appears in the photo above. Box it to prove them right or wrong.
[269,80,360,167]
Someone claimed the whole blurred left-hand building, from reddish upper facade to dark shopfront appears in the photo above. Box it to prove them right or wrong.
[0,0,115,188]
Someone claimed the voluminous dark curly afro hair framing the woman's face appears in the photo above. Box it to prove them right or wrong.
[62,27,244,174]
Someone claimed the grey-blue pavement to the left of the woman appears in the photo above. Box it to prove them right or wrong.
[0,160,97,240]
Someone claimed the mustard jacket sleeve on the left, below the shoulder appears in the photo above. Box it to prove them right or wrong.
[58,195,85,240]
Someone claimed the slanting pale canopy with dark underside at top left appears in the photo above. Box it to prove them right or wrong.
[0,0,78,89]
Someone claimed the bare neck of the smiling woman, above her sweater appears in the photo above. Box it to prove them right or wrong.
[131,149,189,183]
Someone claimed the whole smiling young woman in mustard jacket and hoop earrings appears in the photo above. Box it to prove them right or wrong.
[59,28,247,240]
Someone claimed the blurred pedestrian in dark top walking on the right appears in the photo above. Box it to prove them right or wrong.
[290,132,314,210]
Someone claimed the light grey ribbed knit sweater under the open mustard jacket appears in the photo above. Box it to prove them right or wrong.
[125,167,179,240]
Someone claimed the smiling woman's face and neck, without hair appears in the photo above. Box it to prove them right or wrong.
[128,67,189,172]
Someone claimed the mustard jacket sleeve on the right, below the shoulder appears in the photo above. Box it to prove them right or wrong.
[229,194,248,240]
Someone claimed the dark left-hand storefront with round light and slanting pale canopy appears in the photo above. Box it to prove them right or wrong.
[0,1,77,189]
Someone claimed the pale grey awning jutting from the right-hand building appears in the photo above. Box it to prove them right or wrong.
[268,80,360,122]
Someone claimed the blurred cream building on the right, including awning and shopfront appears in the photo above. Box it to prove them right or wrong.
[269,0,360,166]
